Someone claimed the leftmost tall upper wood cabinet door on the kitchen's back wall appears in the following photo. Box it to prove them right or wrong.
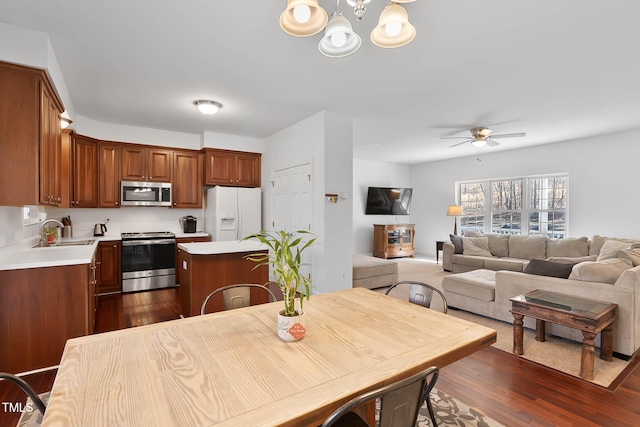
[71,134,100,208]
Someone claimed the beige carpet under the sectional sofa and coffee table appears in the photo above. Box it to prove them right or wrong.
[380,258,632,388]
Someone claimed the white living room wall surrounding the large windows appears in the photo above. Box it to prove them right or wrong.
[410,131,640,256]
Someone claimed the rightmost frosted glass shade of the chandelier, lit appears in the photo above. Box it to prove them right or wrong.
[371,2,416,48]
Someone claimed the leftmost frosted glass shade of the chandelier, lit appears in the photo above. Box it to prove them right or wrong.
[280,0,328,37]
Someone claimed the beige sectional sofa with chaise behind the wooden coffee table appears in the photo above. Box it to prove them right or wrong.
[442,236,640,358]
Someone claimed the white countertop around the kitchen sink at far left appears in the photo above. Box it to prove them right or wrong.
[0,238,99,270]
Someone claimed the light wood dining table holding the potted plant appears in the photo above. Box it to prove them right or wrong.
[43,288,496,427]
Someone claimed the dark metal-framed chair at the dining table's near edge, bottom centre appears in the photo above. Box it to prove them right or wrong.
[322,366,440,427]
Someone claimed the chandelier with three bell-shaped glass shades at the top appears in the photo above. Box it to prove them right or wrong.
[280,0,416,58]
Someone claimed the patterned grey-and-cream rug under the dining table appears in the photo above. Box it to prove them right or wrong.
[17,388,503,427]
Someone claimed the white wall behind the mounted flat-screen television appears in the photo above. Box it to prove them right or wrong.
[353,159,418,254]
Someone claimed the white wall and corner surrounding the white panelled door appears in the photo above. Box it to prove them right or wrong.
[262,112,353,293]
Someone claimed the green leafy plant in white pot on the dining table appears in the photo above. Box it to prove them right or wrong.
[242,230,316,341]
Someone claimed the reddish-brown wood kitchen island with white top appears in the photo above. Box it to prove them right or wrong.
[176,240,269,317]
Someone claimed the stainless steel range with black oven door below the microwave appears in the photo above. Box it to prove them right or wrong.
[120,231,176,292]
